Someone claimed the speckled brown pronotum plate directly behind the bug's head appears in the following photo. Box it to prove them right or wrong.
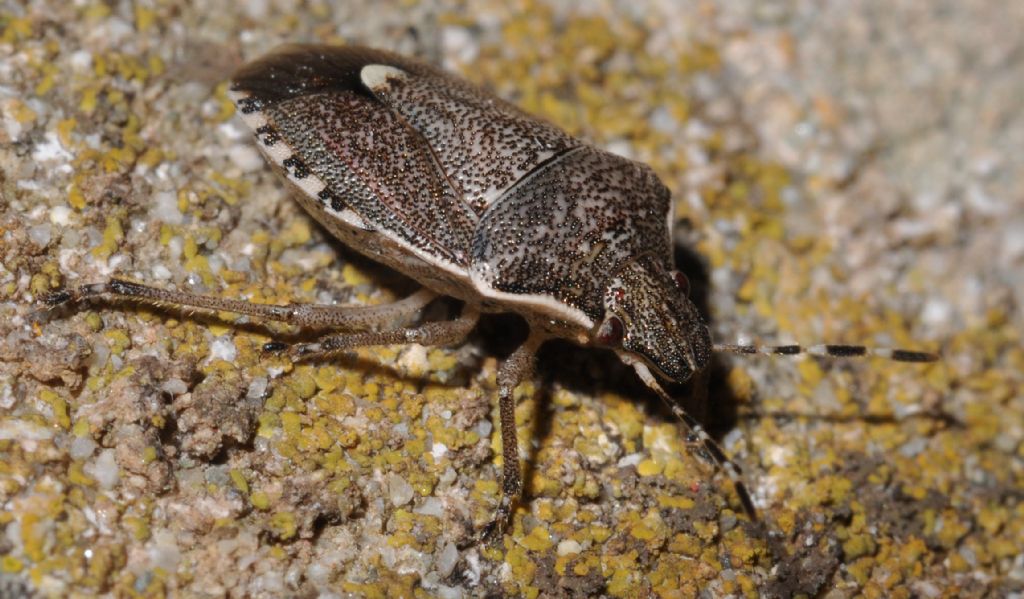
[470,145,672,320]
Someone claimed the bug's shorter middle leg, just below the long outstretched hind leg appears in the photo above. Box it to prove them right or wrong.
[263,306,480,361]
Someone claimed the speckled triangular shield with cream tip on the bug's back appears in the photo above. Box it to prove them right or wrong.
[362,53,581,214]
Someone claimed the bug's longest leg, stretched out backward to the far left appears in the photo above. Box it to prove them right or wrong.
[42,279,437,330]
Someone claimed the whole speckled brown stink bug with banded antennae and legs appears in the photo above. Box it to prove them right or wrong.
[45,45,935,530]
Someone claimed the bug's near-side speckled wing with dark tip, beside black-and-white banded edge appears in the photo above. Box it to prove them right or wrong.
[231,45,477,266]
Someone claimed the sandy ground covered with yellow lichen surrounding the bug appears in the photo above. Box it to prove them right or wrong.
[0,0,1024,597]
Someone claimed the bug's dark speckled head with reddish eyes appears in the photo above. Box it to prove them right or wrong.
[592,257,712,383]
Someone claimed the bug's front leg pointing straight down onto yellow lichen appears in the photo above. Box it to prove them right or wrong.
[481,331,547,539]
